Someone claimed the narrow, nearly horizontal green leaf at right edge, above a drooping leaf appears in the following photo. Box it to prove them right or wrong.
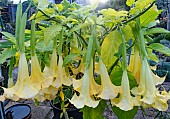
[144,28,170,35]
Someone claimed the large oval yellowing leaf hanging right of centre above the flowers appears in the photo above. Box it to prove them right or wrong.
[101,31,122,66]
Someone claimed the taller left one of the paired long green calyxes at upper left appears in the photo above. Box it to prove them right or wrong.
[15,2,22,48]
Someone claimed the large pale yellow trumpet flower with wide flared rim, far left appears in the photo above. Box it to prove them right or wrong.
[4,52,40,101]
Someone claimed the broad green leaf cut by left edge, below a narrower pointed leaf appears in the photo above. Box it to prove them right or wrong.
[0,49,16,64]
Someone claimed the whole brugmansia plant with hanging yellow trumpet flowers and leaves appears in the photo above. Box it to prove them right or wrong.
[0,0,170,119]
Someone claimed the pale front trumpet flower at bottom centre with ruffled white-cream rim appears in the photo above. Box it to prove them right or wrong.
[70,67,99,108]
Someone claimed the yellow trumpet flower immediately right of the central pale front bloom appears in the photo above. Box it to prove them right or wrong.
[98,58,119,100]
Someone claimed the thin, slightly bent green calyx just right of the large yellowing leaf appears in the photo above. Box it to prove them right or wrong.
[119,27,127,71]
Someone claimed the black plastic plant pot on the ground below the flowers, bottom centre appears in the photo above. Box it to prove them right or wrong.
[50,102,83,119]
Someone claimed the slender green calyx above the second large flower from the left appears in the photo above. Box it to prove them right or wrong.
[30,20,36,56]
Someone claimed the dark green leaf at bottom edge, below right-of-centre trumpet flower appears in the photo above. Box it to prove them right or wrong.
[112,107,138,119]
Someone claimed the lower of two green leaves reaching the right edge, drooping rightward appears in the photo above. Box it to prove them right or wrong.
[149,43,170,56]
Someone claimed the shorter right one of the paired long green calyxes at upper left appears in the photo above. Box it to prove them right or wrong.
[19,13,27,52]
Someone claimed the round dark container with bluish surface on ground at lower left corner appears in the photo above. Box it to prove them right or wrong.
[5,104,31,119]
